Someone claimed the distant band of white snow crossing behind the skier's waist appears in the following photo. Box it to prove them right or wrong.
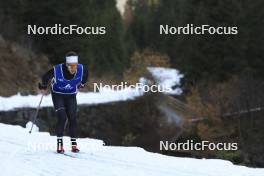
[0,67,183,111]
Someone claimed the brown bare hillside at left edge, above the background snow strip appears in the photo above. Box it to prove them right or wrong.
[0,35,50,96]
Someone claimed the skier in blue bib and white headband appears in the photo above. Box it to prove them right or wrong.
[39,51,88,153]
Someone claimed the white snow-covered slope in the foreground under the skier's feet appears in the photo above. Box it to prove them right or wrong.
[0,124,264,176]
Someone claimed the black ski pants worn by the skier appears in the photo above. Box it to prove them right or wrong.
[52,93,77,138]
